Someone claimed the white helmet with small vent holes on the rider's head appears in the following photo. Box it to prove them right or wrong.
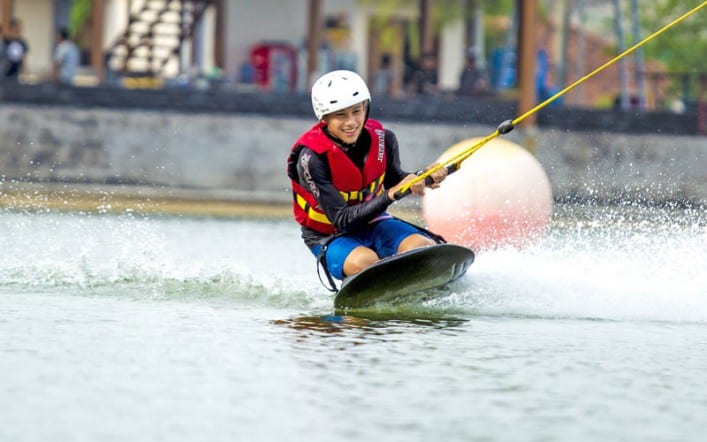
[312,70,371,120]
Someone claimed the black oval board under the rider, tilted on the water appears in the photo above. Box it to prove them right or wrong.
[334,244,474,309]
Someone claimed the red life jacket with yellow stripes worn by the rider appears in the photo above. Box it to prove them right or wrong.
[287,118,387,235]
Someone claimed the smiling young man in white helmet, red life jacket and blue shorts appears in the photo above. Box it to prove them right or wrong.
[287,70,447,282]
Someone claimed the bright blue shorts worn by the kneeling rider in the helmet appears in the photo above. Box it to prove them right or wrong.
[311,218,429,280]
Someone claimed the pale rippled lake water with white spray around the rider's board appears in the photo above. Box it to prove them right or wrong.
[0,202,707,442]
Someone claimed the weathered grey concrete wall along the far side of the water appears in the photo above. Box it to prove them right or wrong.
[0,103,707,204]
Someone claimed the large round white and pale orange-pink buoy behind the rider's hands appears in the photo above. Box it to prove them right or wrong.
[422,138,552,251]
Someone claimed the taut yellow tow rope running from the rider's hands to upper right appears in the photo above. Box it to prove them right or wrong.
[396,1,707,198]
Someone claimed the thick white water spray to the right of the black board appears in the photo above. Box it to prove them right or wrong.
[458,203,707,322]
